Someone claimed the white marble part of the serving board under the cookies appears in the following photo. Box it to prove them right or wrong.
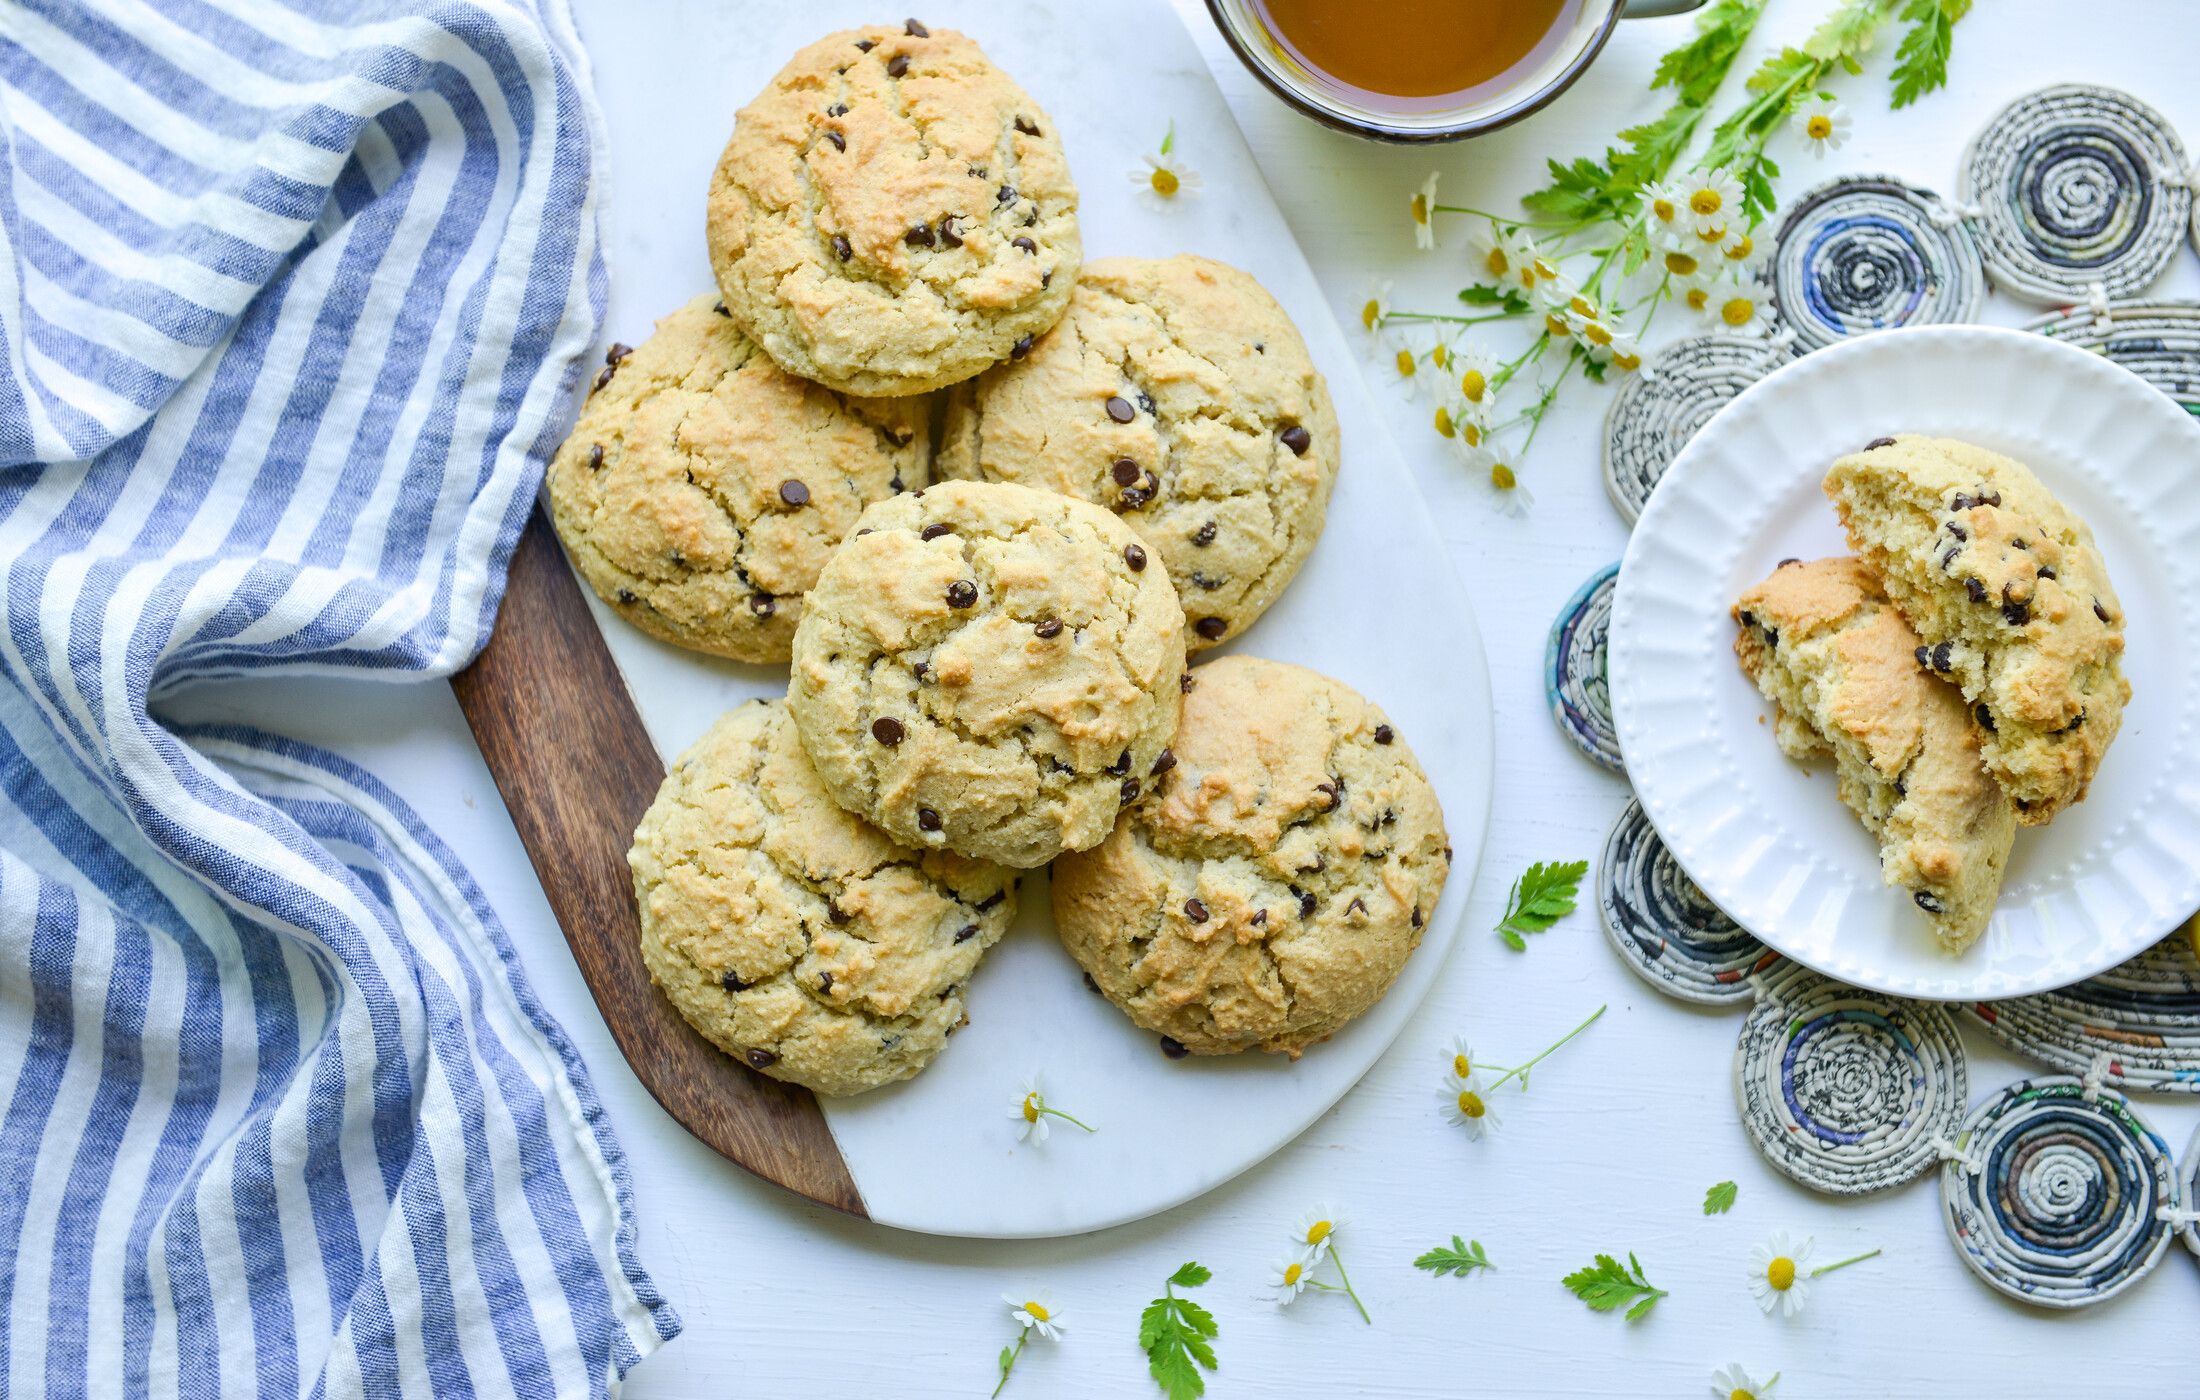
[572,0,1492,1235]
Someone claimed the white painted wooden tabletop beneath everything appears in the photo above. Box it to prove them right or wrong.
[171,0,2200,1400]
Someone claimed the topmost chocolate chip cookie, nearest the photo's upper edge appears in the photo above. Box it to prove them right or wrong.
[706,20,1080,396]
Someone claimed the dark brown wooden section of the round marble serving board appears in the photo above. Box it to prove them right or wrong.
[451,508,865,1215]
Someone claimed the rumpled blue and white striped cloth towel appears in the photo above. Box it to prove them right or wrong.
[0,0,680,1396]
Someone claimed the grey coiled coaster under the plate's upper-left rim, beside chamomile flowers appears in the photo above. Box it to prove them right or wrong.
[1604,335,1786,524]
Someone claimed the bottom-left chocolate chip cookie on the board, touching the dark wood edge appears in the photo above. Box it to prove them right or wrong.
[627,700,1016,1094]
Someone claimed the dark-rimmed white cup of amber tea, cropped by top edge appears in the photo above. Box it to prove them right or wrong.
[1208,0,1703,141]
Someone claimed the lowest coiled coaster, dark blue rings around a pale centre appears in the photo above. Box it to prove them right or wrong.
[1940,1074,2180,1308]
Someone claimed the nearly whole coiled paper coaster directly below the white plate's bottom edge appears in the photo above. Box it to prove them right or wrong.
[1734,966,1967,1195]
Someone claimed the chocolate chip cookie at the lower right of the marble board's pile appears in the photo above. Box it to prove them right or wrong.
[1054,656,1452,1059]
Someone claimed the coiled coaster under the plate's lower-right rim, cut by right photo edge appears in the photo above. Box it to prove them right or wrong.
[1962,925,2200,1094]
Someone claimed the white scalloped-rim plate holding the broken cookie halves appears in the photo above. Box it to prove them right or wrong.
[1610,326,2200,1002]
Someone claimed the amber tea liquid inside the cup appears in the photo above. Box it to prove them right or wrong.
[1254,0,1582,110]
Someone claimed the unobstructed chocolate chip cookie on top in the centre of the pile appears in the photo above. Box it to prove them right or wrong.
[788,482,1184,867]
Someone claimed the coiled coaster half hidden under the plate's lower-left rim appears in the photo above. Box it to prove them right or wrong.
[1597,799,1784,1008]
